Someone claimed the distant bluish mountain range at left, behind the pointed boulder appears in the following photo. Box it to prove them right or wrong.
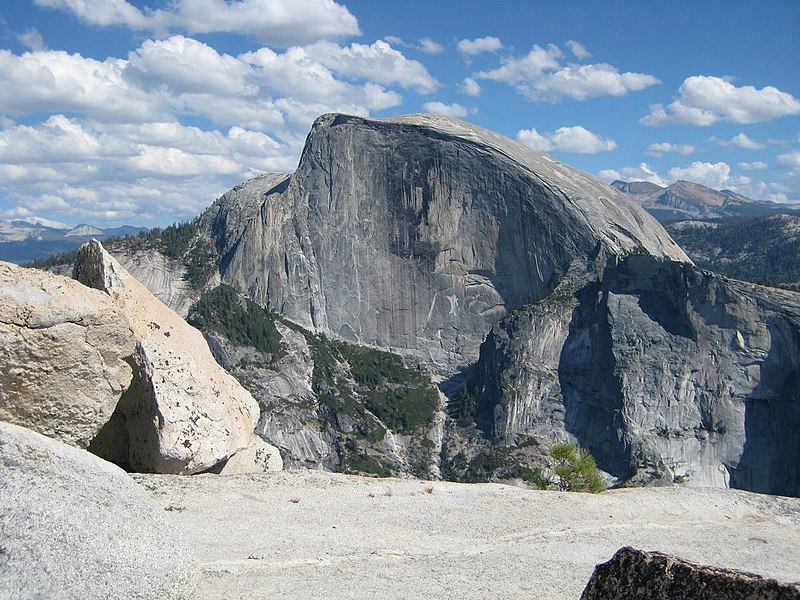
[0,221,147,263]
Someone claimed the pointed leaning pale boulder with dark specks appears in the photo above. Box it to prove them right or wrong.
[74,241,280,474]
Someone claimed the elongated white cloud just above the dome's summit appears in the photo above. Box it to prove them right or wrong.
[300,40,439,94]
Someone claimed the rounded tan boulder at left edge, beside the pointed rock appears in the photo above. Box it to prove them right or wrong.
[0,263,136,448]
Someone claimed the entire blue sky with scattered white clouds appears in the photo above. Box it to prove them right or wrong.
[0,0,800,226]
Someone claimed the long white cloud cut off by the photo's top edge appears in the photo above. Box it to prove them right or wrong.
[35,0,360,46]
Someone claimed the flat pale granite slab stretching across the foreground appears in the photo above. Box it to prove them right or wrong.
[139,470,800,600]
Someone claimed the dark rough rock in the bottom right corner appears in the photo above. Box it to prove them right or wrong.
[581,546,800,600]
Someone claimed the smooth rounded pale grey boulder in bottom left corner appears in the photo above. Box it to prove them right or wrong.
[0,422,194,600]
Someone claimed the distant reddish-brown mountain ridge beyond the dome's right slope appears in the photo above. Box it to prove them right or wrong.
[611,180,800,222]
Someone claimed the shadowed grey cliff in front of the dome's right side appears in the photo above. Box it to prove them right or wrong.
[468,255,800,495]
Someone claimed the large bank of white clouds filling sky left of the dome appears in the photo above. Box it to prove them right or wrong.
[0,26,444,225]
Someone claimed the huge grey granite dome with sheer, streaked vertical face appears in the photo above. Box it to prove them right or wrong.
[203,114,690,374]
